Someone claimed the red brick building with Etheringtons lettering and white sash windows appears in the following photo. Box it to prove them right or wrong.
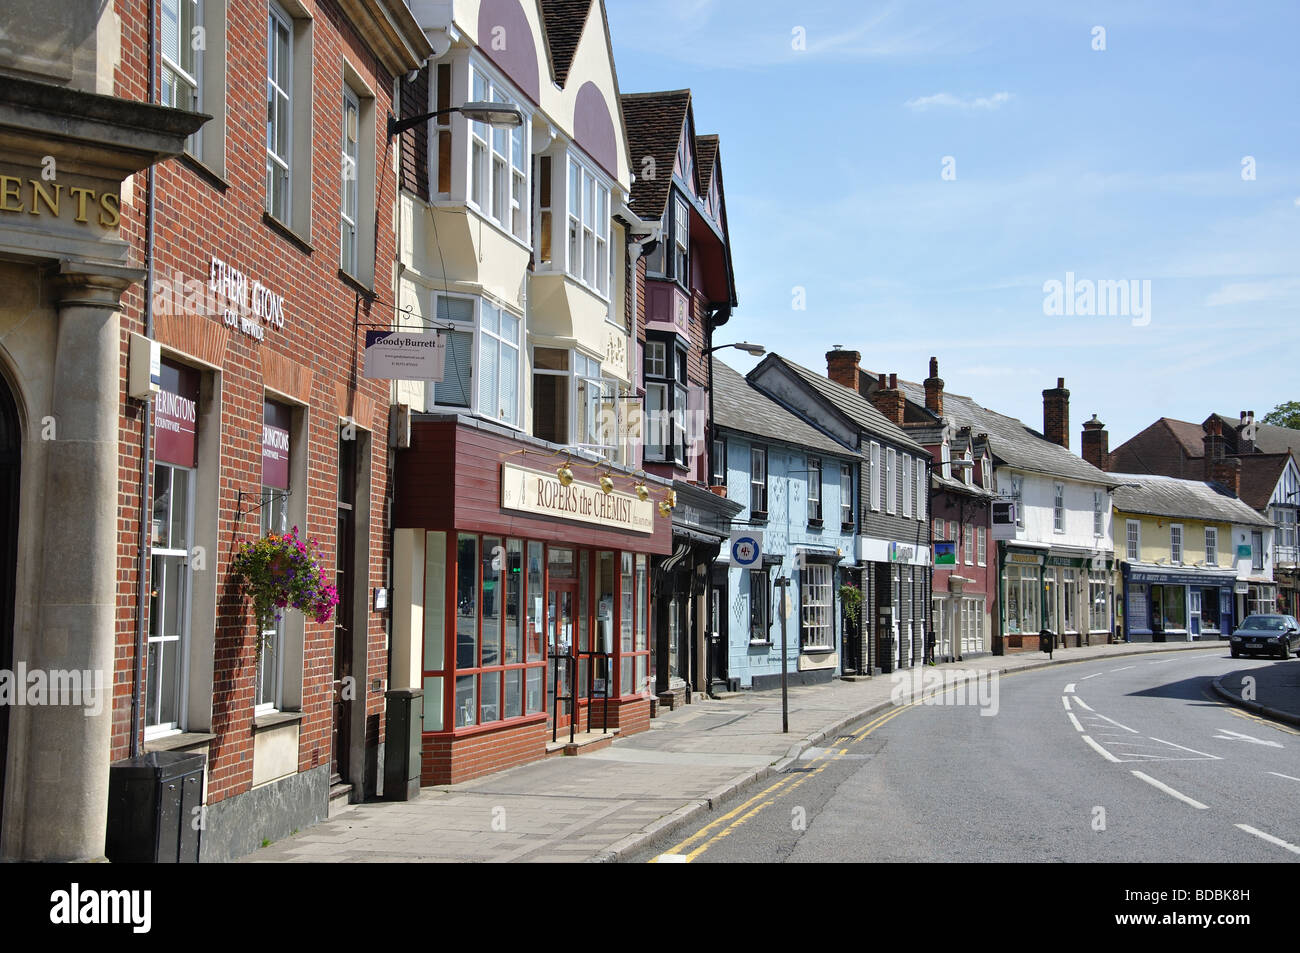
[112,0,430,859]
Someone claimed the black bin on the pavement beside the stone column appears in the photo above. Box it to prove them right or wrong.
[104,751,207,863]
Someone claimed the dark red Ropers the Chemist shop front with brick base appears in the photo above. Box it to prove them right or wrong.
[391,415,672,784]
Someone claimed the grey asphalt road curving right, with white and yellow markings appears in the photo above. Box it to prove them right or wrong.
[629,646,1300,863]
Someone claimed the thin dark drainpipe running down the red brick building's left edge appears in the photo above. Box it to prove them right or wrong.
[130,0,159,758]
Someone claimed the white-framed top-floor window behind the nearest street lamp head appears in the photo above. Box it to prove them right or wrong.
[469,66,532,242]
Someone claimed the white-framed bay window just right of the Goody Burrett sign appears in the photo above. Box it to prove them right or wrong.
[433,294,523,426]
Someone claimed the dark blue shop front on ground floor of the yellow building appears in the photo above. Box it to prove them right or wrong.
[1121,562,1236,642]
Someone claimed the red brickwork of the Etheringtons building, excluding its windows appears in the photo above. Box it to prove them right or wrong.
[112,0,395,802]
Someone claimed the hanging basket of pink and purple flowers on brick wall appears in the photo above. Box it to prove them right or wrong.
[230,527,338,660]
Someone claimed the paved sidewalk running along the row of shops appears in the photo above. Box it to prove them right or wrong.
[243,642,1216,863]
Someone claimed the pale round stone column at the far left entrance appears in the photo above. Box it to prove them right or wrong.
[14,261,140,861]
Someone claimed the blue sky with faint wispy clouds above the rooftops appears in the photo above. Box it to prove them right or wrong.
[606,0,1300,451]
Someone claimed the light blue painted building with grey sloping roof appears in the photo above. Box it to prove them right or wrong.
[712,363,861,689]
